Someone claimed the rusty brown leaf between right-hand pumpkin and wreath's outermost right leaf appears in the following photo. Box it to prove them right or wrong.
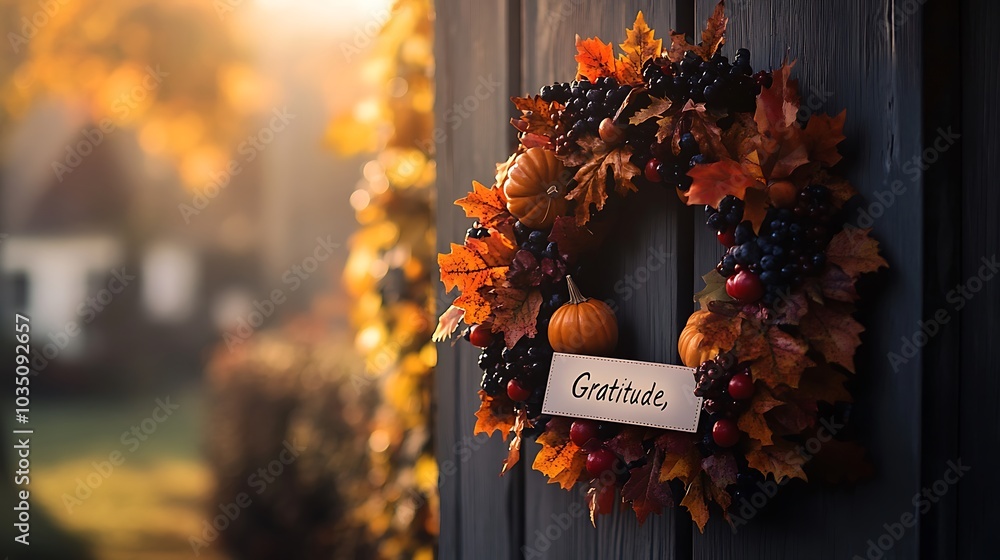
[734,319,816,388]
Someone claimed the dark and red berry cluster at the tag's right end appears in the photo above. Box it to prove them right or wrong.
[694,352,754,456]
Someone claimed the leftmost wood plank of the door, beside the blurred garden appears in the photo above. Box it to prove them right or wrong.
[435,0,521,560]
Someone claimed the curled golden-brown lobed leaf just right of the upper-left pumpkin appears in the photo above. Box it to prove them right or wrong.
[566,145,640,226]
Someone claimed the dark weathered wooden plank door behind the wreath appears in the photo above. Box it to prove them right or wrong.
[436,0,1000,559]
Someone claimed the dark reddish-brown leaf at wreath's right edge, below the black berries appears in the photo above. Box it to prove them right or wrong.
[799,301,865,373]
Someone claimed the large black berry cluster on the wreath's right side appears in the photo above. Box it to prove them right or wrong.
[707,189,839,305]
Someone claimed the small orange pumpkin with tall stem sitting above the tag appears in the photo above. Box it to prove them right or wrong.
[548,276,618,356]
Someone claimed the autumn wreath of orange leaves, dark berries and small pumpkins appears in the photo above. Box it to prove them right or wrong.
[435,2,886,529]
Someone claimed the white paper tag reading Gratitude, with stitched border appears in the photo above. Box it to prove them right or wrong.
[542,352,702,432]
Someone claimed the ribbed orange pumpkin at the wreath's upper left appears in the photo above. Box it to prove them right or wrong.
[503,148,569,229]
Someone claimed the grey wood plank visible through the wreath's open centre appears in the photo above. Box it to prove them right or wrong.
[522,0,691,559]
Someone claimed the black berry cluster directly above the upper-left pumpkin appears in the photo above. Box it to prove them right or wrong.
[539,77,632,155]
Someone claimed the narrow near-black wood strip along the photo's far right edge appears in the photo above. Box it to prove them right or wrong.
[956,1,1000,559]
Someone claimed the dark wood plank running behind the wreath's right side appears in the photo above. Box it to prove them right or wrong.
[693,0,923,559]
